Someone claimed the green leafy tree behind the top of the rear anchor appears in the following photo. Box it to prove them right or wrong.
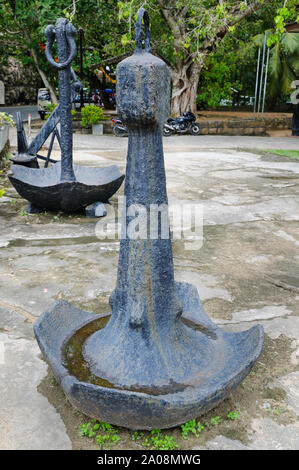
[0,0,121,103]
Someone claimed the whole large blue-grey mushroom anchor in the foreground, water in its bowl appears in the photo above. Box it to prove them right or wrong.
[35,8,263,429]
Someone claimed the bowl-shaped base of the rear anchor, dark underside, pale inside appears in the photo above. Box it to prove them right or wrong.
[9,162,124,212]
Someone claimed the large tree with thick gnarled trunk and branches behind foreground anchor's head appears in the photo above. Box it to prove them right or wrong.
[114,0,276,115]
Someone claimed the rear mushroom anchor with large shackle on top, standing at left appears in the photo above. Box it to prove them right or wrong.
[9,18,124,212]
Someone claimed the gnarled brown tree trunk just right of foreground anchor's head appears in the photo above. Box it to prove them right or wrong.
[170,66,200,117]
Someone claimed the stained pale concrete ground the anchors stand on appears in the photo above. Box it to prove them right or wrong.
[0,131,299,450]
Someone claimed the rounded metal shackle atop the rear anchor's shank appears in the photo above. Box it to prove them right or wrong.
[45,18,77,70]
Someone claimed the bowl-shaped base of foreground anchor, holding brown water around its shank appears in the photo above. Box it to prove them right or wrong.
[34,283,264,430]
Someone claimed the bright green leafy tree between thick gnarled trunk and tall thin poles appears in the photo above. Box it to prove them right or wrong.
[197,0,290,108]
